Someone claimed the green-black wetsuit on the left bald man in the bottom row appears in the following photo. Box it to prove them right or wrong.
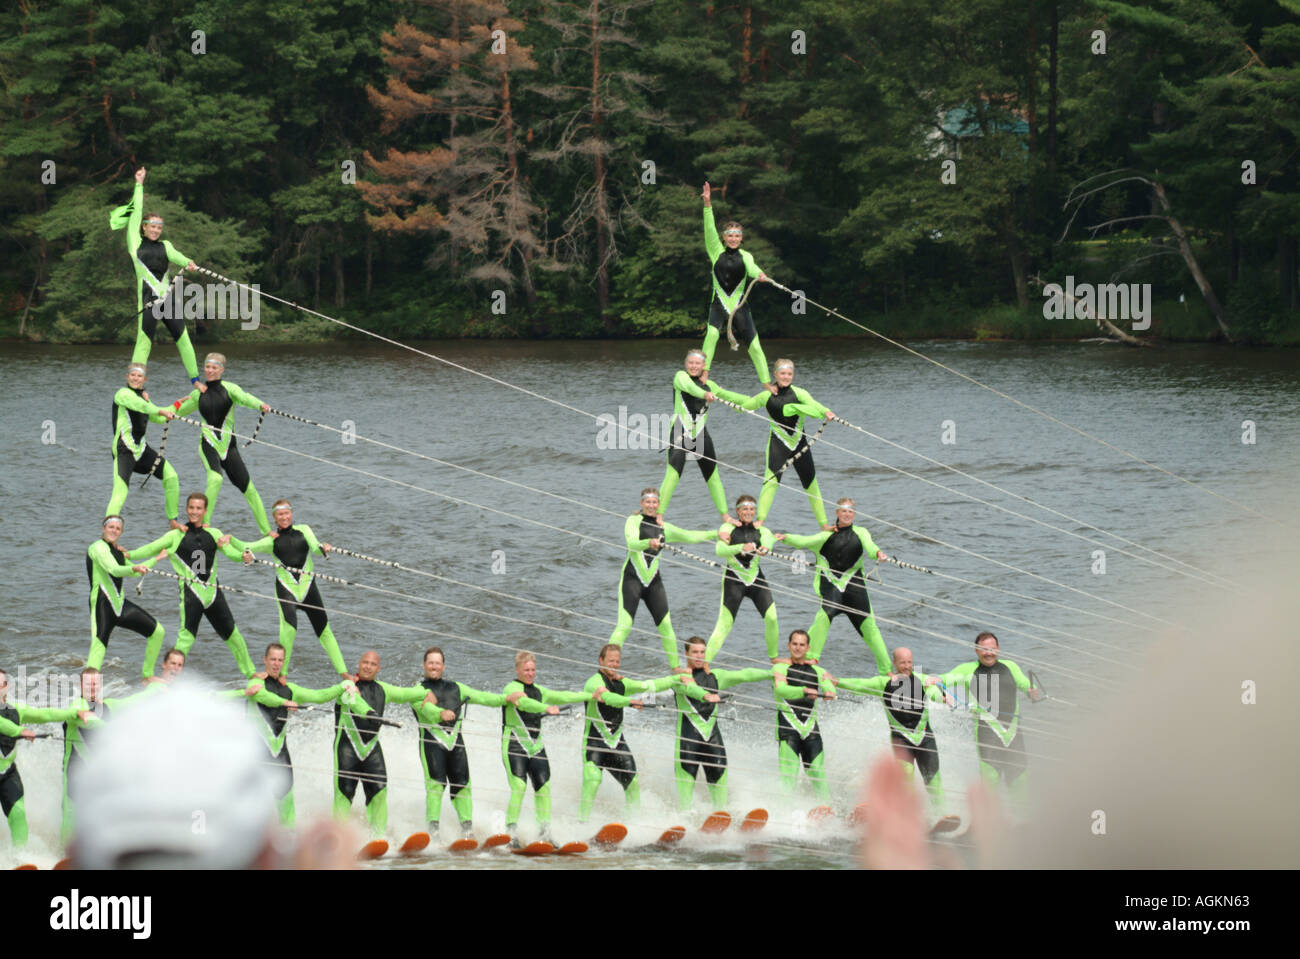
[334,680,425,836]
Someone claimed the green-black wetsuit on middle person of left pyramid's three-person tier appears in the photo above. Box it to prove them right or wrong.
[159,522,254,678]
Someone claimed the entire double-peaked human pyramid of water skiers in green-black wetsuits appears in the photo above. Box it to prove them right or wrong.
[0,168,1040,850]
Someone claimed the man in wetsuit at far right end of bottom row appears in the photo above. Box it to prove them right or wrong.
[931,632,1040,799]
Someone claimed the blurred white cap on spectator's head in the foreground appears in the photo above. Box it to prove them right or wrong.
[69,684,277,869]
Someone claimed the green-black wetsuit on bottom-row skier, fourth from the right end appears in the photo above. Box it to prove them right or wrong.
[673,669,772,812]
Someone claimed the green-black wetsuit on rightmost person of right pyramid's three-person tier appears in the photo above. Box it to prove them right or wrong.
[785,522,889,674]
